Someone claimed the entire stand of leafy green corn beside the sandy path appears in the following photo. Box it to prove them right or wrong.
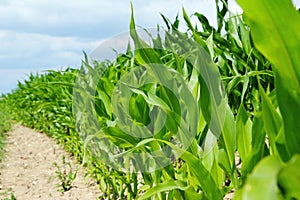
[2,0,300,199]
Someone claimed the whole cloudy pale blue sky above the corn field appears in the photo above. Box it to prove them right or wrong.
[0,0,300,94]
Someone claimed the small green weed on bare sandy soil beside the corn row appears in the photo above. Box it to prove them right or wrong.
[53,155,78,192]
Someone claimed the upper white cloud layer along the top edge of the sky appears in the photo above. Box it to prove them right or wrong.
[0,0,218,39]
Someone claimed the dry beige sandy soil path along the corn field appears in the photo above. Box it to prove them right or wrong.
[0,125,101,200]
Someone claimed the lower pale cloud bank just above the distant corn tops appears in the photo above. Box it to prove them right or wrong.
[0,30,102,94]
